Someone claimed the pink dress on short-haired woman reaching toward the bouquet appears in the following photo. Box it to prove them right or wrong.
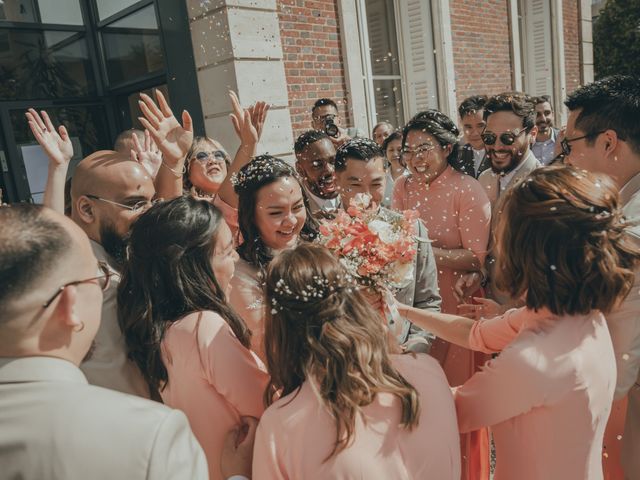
[455,308,616,480]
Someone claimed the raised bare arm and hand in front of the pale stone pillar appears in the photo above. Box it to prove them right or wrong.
[218,92,269,208]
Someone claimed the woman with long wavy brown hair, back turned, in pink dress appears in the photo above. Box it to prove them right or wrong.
[253,244,460,480]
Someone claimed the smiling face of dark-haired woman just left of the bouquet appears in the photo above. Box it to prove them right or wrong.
[255,177,307,250]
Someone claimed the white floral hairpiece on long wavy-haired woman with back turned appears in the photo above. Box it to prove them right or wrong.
[271,274,356,315]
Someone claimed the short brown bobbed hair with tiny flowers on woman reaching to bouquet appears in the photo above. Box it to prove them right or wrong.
[495,166,640,315]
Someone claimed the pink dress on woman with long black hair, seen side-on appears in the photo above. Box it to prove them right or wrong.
[160,312,269,480]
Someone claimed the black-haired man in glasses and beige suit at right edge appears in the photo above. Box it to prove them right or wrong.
[561,75,640,479]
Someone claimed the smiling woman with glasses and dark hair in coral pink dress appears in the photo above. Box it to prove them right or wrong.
[393,110,491,479]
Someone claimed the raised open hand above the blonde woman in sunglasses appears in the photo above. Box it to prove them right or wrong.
[138,90,193,167]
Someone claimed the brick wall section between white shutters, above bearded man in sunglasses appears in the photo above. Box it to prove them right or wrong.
[449,0,512,109]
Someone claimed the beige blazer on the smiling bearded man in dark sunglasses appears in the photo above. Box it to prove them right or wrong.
[478,150,540,303]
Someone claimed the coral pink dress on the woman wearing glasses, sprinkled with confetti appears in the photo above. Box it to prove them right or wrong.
[393,166,491,480]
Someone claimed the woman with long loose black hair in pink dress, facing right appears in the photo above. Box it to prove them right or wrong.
[118,196,268,479]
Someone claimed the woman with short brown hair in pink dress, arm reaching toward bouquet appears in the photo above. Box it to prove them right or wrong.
[401,167,640,480]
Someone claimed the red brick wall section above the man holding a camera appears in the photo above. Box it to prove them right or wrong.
[278,0,349,138]
